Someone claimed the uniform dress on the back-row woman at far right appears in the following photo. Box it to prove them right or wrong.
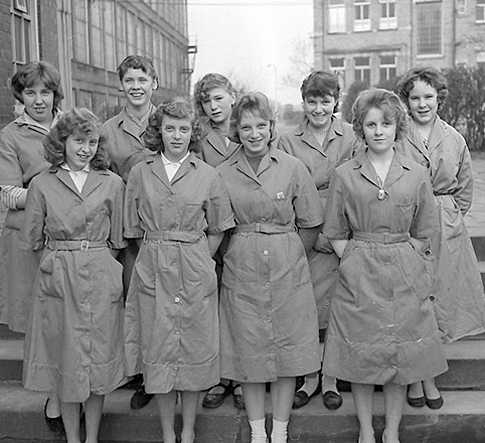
[398,117,485,342]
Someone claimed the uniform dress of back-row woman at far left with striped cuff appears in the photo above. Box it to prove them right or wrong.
[0,112,53,332]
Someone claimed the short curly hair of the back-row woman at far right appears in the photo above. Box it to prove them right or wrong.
[397,66,448,110]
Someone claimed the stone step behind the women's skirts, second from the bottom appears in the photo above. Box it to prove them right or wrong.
[0,334,485,391]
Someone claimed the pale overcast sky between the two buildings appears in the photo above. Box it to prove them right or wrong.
[188,0,313,104]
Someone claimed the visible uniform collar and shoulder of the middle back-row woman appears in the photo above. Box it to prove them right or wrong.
[198,119,238,168]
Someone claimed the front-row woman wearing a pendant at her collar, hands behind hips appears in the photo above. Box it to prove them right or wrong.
[323,89,447,443]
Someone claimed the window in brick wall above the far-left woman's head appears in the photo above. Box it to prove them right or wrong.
[10,0,39,71]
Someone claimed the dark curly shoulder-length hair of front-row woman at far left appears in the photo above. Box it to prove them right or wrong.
[43,108,109,170]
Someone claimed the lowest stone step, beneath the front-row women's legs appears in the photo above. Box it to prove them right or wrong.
[0,384,485,443]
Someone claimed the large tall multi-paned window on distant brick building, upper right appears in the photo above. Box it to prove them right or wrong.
[416,2,442,55]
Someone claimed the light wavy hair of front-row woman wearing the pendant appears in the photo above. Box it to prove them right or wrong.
[352,89,409,140]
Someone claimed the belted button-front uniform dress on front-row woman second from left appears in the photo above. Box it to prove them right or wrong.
[125,153,234,394]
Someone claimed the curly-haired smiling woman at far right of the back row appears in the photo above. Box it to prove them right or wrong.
[398,66,485,409]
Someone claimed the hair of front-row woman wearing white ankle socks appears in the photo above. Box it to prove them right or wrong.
[228,92,276,143]
